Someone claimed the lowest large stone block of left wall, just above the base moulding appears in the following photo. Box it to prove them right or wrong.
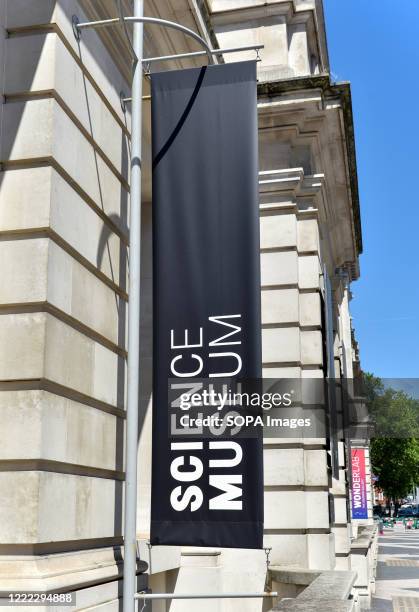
[0,471,122,544]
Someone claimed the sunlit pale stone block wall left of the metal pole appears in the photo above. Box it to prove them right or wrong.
[0,0,135,607]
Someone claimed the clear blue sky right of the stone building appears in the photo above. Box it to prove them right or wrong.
[324,0,419,378]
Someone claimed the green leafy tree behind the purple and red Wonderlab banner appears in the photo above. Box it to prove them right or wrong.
[363,374,419,499]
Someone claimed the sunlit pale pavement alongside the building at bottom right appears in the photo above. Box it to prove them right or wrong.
[372,527,419,612]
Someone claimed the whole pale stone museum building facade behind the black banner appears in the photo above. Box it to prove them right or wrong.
[0,0,369,612]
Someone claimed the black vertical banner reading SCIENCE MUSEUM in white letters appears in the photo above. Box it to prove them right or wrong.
[151,62,263,548]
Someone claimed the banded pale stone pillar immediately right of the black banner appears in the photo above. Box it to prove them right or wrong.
[261,171,334,569]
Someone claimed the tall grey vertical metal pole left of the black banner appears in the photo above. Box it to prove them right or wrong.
[123,0,144,612]
